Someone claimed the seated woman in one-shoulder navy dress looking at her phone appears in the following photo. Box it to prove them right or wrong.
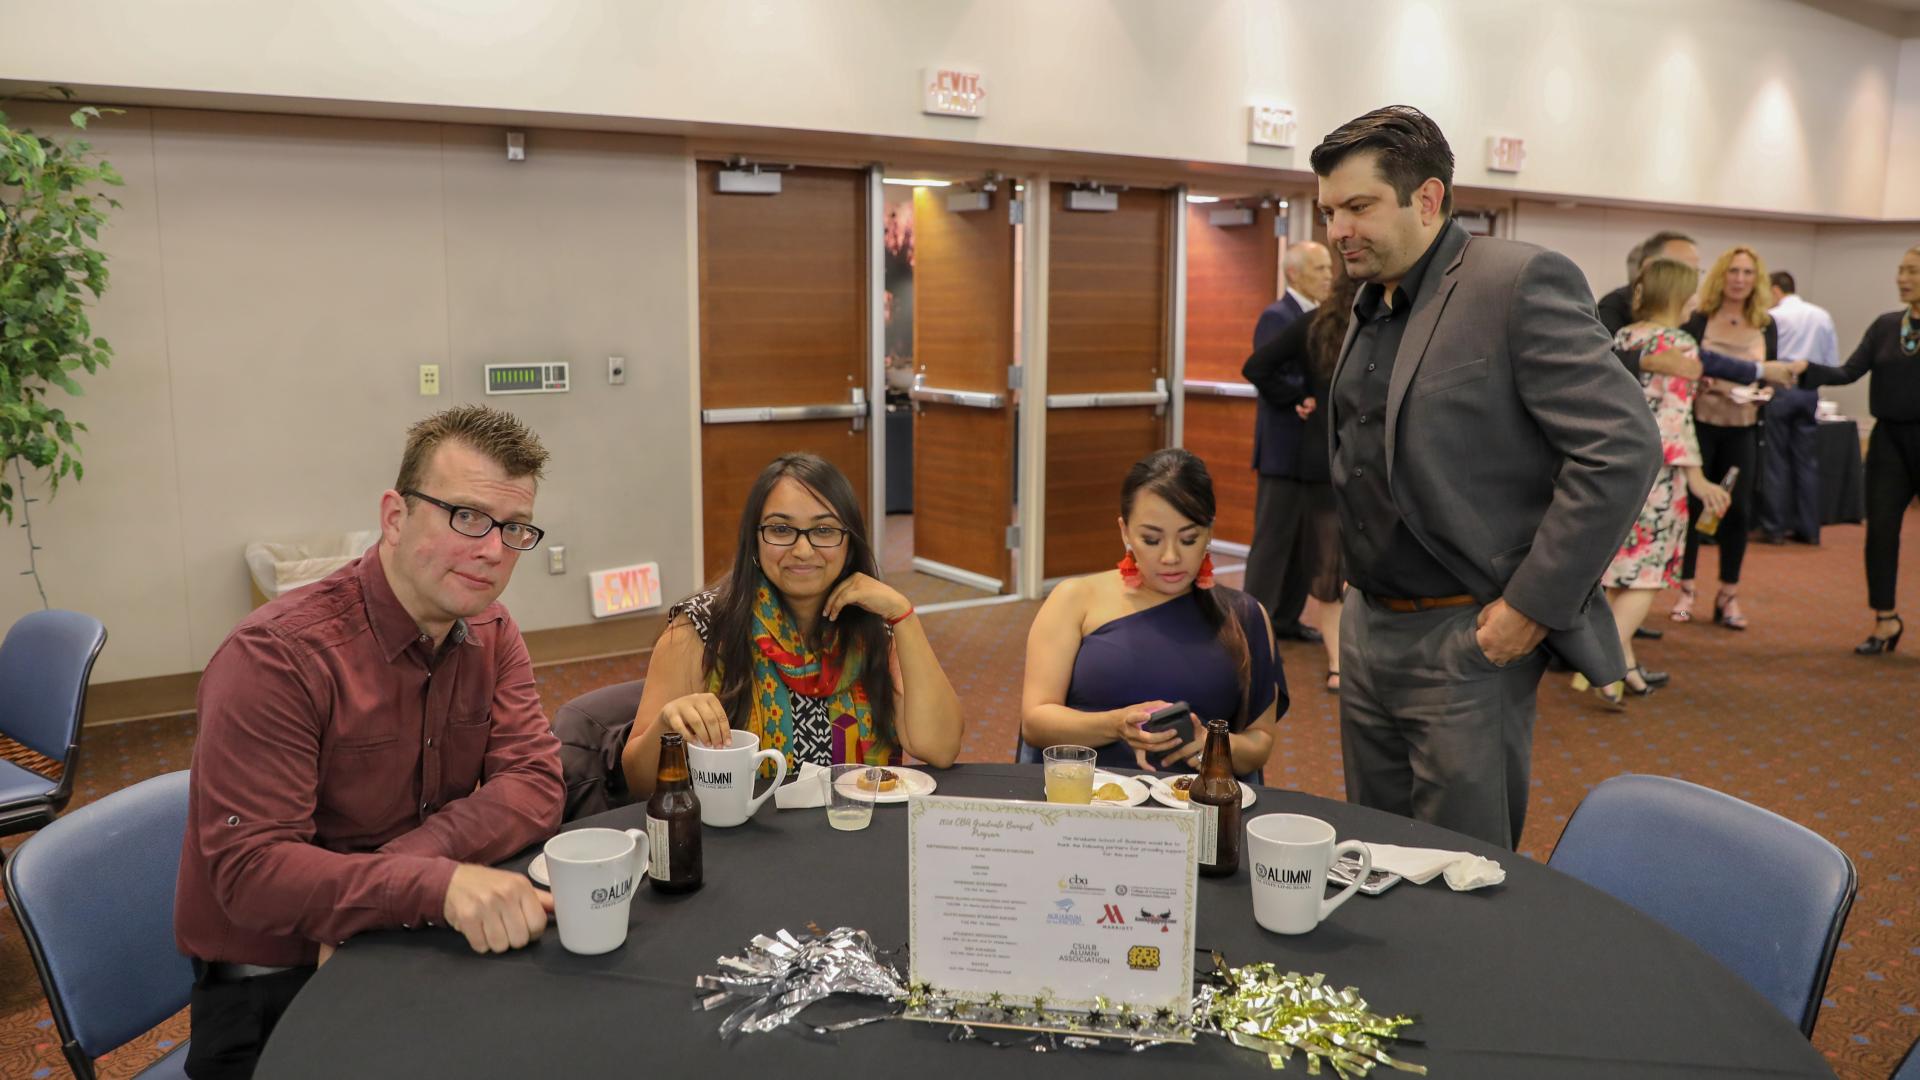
[1020,450,1286,774]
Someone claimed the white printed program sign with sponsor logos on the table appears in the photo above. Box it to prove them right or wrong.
[906,796,1198,1017]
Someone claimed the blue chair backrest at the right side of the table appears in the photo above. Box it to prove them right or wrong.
[1548,774,1857,1036]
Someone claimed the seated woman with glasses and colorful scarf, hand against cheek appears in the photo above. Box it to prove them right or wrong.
[620,454,962,799]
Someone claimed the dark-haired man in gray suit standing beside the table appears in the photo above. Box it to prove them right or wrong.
[1311,106,1661,847]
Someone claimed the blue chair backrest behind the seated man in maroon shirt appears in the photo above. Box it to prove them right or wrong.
[6,771,194,1076]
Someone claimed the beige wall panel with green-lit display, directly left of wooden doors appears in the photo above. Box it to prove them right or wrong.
[442,127,695,628]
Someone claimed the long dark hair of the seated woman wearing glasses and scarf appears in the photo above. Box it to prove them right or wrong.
[701,454,899,748]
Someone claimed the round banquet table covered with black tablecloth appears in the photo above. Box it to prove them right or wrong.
[259,765,1832,1080]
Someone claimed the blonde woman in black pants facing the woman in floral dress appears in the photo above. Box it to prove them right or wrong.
[1672,246,1780,630]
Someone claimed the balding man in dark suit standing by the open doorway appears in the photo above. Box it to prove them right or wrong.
[1246,240,1332,642]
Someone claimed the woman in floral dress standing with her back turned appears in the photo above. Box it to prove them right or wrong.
[1594,258,1730,707]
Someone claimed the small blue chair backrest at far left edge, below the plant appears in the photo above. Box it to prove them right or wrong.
[0,611,108,763]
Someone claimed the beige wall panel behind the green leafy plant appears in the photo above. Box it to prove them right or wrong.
[0,104,196,680]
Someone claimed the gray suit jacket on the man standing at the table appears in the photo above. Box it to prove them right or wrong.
[1323,225,1663,686]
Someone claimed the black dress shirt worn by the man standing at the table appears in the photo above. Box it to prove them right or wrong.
[1332,225,1467,600]
